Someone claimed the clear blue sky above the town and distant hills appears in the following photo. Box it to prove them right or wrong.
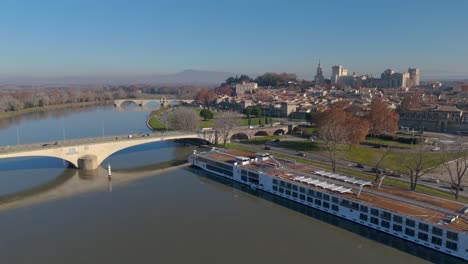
[0,0,468,78]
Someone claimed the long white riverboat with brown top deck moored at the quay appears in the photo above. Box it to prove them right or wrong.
[189,148,468,260]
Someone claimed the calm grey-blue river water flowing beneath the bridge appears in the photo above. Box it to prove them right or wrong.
[0,106,462,264]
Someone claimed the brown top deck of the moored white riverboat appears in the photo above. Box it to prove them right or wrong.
[198,150,468,232]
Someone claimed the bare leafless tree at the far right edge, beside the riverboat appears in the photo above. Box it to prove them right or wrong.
[444,144,468,200]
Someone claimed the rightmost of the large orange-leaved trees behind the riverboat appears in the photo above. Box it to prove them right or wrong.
[367,97,400,136]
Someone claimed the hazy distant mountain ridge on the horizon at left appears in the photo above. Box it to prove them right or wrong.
[0,69,239,85]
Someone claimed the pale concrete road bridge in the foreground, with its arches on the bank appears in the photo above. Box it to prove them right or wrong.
[0,126,288,170]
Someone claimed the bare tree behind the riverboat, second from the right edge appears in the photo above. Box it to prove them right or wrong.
[399,138,435,191]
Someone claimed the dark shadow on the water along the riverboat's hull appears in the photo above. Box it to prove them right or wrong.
[186,166,466,264]
